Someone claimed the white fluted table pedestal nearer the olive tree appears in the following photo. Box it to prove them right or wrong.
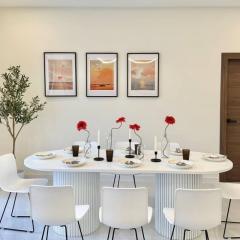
[53,172,100,237]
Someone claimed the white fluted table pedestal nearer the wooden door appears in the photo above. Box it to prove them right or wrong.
[155,173,201,239]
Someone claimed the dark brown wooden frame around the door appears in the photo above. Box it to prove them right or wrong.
[220,53,240,181]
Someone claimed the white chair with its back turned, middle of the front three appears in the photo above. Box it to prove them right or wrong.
[99,187,152,240]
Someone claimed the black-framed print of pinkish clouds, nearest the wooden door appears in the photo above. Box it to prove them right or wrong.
[127,52,159,97]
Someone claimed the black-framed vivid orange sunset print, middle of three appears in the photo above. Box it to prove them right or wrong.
[86,52,118,97]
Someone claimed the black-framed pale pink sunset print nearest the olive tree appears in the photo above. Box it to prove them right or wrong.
[44,52,77,97]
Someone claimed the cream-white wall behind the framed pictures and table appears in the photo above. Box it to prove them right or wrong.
[0,8,240,167]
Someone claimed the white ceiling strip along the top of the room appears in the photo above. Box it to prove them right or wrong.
[0,0,240,7]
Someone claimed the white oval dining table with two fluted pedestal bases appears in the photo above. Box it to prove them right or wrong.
[24,150,233,239]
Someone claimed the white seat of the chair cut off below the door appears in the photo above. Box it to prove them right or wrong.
[219,182,240,199]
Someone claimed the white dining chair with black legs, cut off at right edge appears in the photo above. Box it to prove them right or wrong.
[219,182,240,239]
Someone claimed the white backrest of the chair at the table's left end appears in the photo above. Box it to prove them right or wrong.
[0,153,18,189]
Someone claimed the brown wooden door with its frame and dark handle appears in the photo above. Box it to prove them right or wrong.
[220,53,240,182]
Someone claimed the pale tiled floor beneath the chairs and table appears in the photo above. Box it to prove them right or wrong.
[0,192,240,240]
